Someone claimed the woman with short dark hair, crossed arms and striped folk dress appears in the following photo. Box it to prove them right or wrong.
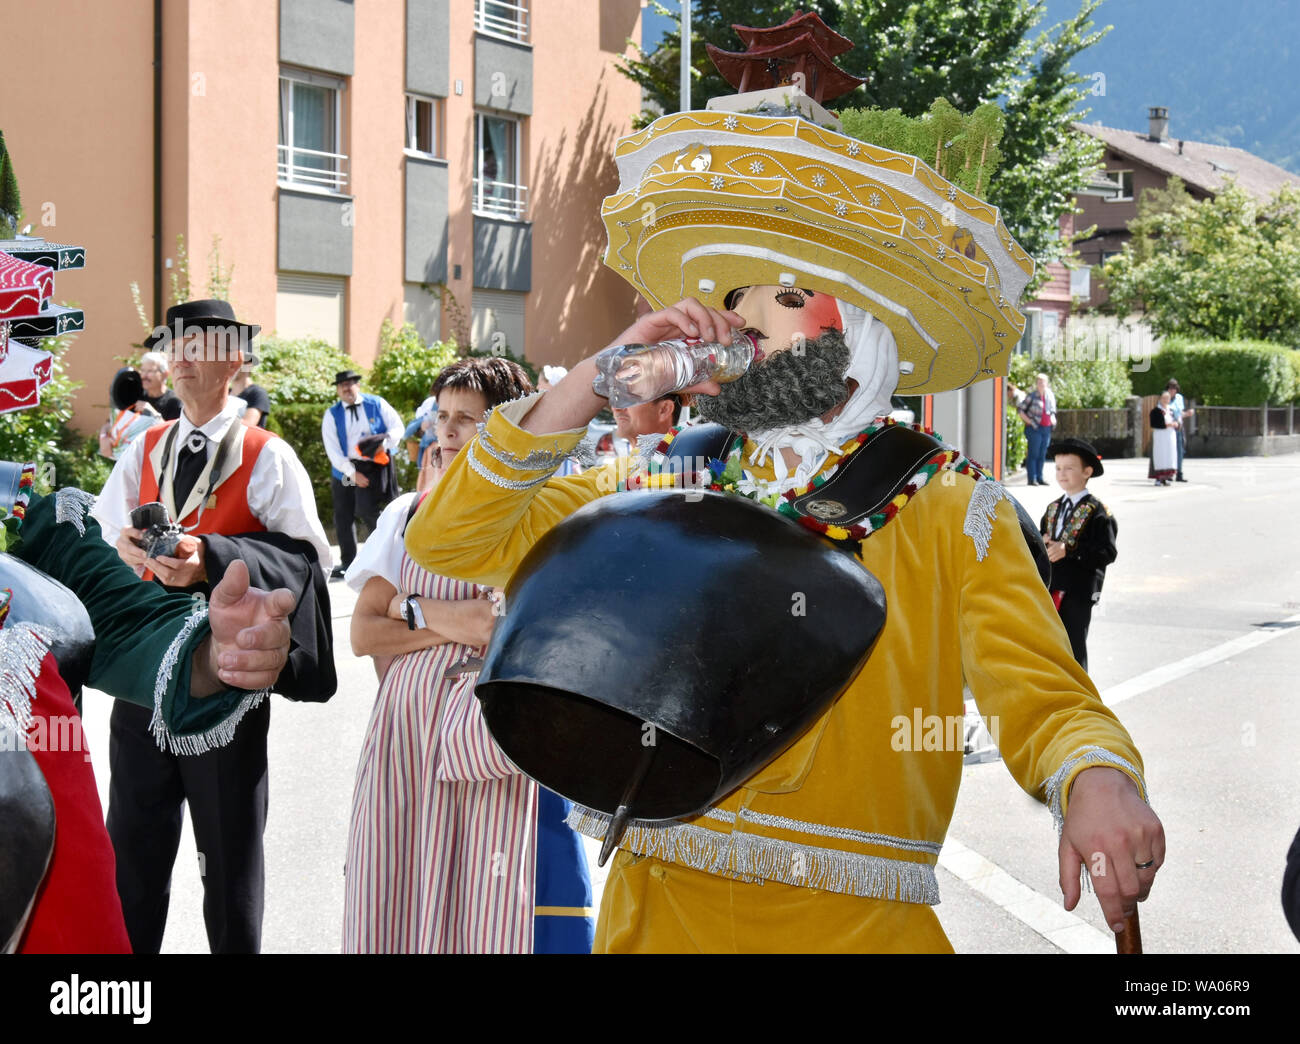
[343,359,537,953]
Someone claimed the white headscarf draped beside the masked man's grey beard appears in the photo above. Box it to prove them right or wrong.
[749,300,898,491]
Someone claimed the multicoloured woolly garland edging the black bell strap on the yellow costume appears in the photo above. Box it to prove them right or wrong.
[647,417,992,542]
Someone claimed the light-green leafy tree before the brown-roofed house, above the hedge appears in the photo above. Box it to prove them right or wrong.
[1102,178,1300,347]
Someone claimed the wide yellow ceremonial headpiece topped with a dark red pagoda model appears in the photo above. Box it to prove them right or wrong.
[602,14,1034,394]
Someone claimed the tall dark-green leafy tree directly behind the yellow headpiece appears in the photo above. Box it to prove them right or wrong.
[620,0,1108,286]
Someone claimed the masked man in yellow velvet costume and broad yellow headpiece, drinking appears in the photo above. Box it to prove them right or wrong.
[407,16,1165,952]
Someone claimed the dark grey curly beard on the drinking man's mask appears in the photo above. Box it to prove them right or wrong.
[694,330,850,432]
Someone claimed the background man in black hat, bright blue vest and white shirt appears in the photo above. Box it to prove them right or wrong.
[321,369,406,580]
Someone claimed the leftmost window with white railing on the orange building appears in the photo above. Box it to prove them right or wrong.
[277,69,347,192]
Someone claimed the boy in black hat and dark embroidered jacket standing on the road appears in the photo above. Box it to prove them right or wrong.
[1039,438,1119,671]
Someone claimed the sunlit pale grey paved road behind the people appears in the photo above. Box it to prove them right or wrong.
[78,455,1300,953]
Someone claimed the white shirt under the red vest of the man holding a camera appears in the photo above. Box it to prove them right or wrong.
[91,397,333,573]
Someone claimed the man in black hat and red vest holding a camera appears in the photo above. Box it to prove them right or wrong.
[92,300,337,953]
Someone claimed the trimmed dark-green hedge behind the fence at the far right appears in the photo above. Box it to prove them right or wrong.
[1134,337,1300,406]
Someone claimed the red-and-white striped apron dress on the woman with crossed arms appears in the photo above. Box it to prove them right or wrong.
[343,554,537,953]
